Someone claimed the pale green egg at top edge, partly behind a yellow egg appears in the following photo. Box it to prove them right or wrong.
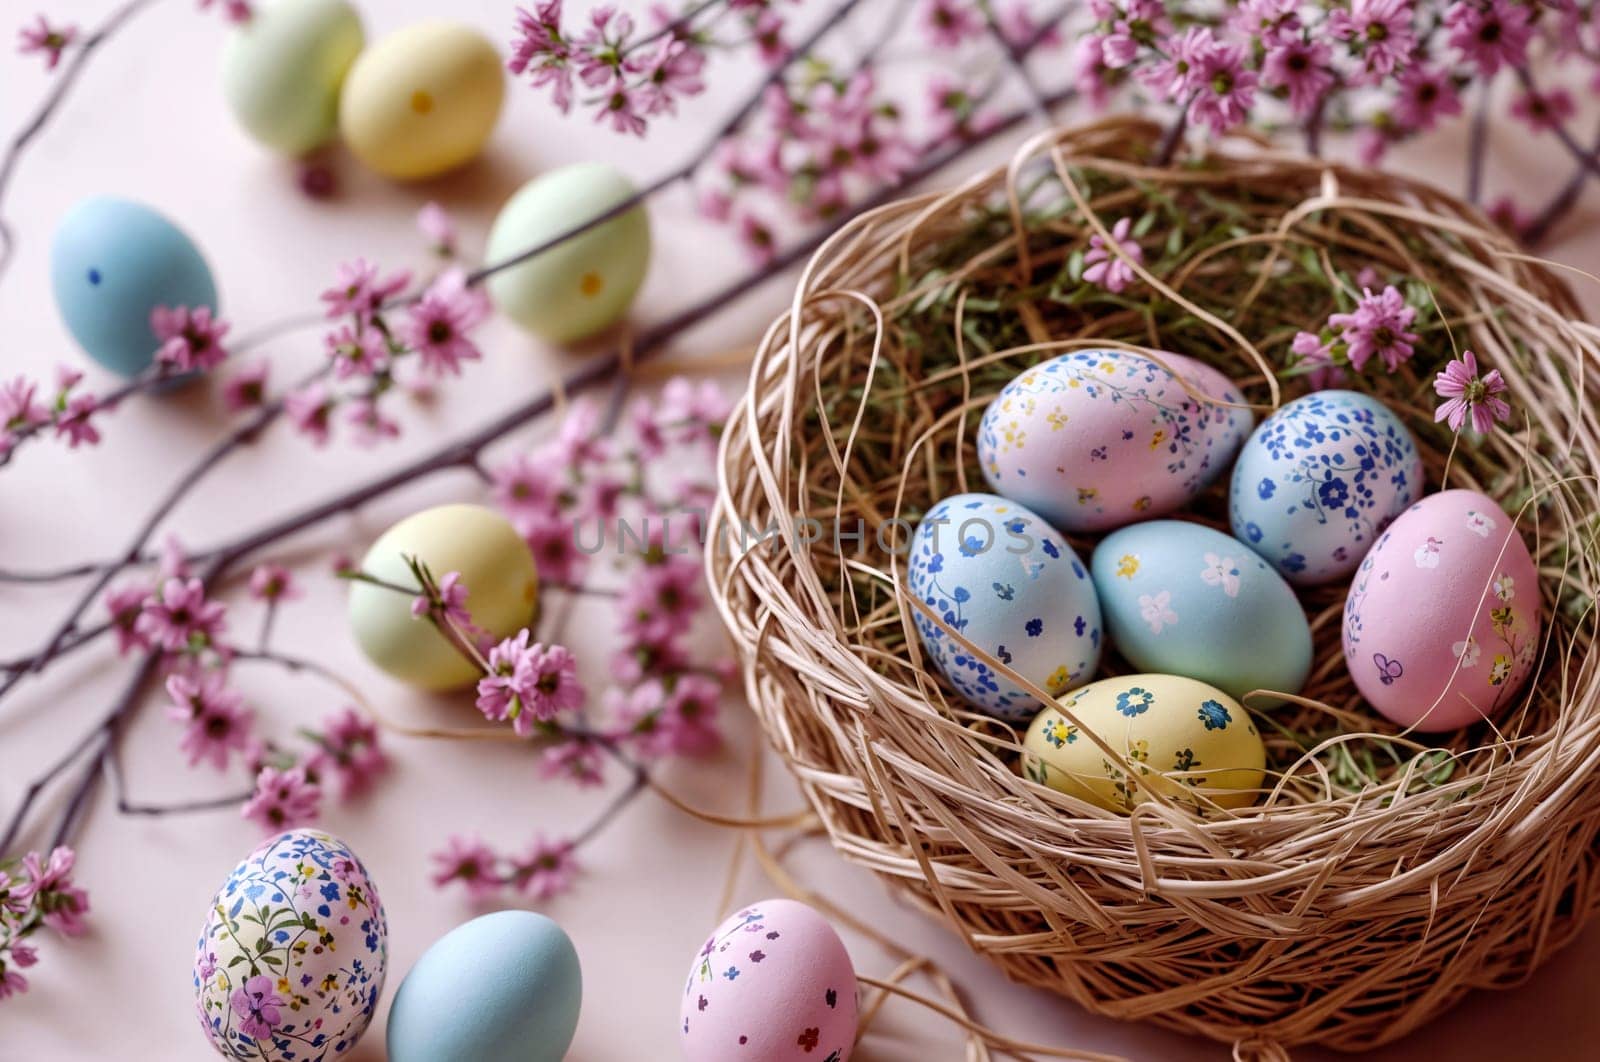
[222,0,366,155]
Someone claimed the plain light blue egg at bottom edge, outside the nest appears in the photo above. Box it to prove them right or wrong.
[389,910,582,1062]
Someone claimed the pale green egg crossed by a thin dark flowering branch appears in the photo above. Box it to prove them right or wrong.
[485,162,650,342]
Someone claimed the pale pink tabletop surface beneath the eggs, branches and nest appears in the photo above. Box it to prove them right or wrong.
[0,0,1600,1062]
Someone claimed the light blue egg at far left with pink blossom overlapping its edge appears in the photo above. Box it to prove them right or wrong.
[50,197,216,376]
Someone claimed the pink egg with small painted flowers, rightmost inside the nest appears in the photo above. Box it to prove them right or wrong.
[1344,491,1542,733]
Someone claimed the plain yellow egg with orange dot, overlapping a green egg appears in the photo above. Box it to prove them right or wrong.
[339,19,506,181]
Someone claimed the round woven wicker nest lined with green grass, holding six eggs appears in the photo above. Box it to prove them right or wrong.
[709,120,1600,1056]
